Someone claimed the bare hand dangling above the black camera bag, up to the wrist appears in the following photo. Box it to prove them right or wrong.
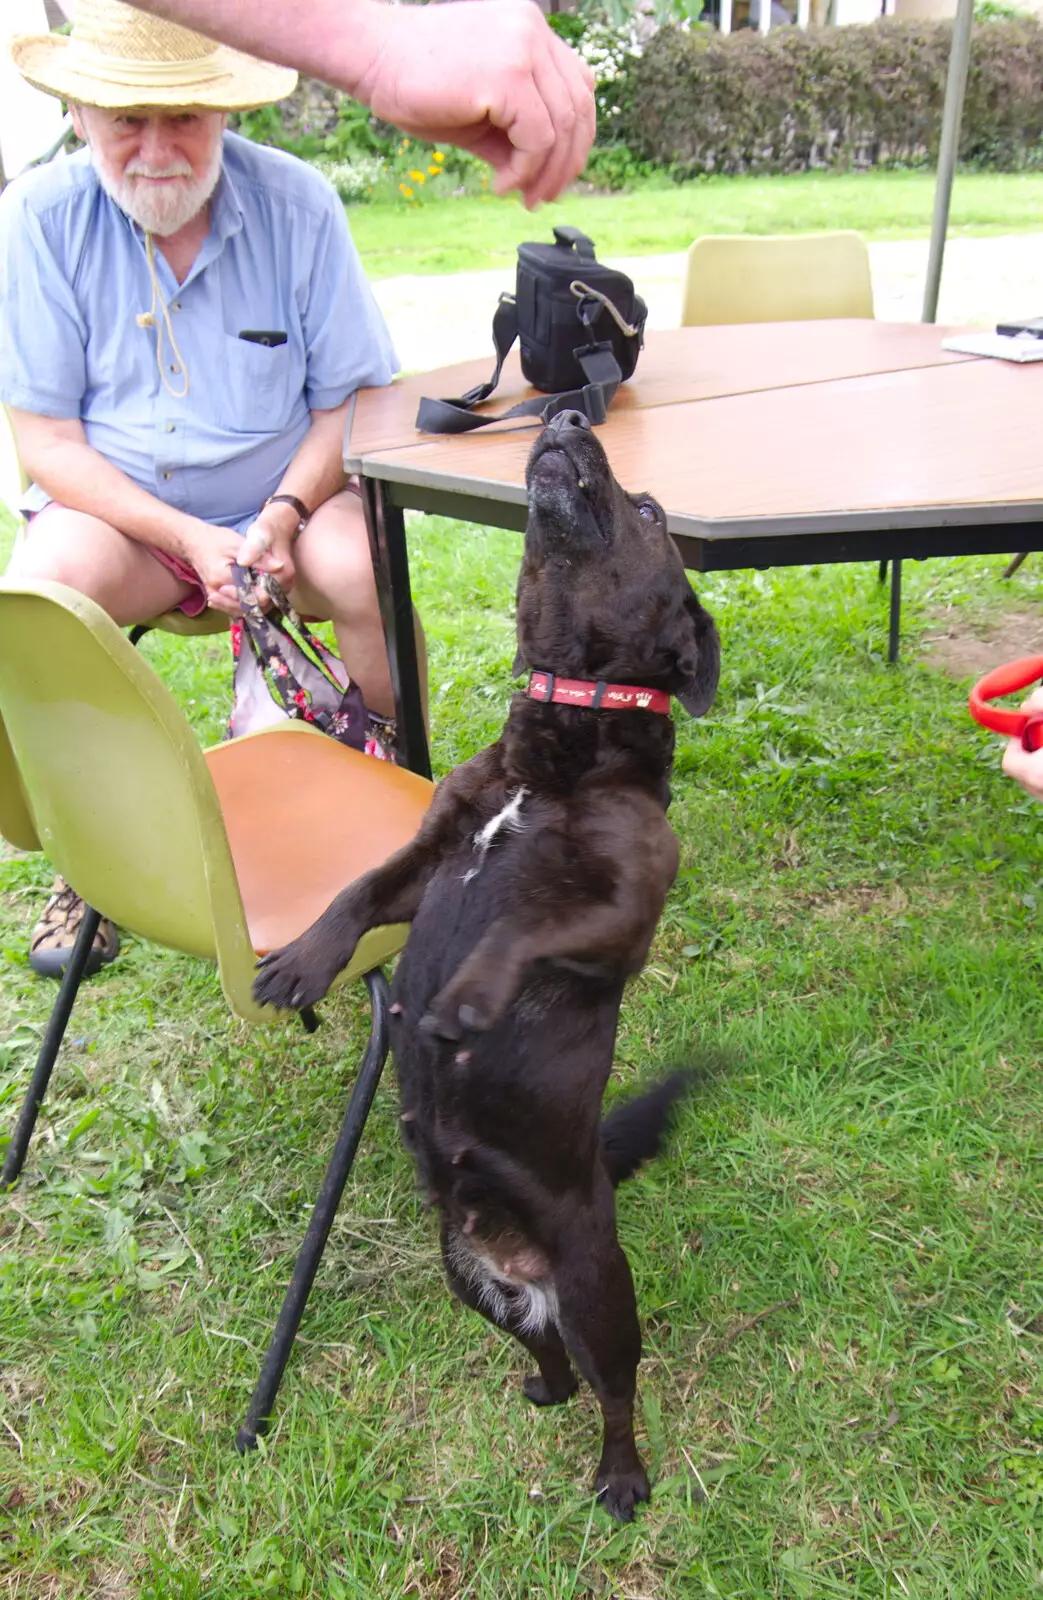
[350,0,595,208]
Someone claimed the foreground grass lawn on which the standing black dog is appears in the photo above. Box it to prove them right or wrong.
[0,502,1043,1600]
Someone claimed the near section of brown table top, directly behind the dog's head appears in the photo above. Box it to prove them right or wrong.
[348,348,1043,538]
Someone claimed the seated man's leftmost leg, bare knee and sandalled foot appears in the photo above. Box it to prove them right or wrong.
[5,506,192,978]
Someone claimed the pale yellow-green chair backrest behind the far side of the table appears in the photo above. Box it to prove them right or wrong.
[681,230,873,328]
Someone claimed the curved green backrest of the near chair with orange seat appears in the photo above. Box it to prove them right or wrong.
[0,582,253,1010]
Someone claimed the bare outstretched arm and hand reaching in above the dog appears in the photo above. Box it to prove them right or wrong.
[126,0,595,206]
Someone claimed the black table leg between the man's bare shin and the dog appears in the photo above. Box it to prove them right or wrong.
[362,477,430,778]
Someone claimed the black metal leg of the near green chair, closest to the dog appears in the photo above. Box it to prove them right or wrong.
[235,966,389,1454]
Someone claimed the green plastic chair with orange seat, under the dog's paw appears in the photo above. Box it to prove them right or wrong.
[0,582,434,1450]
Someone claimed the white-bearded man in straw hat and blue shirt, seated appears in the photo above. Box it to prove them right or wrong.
[0,0,397,974]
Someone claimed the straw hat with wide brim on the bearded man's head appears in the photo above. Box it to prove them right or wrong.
[10,0,298,110]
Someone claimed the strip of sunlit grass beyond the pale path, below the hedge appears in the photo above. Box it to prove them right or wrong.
[349,170,1043,278]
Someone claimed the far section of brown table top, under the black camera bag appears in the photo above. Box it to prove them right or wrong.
[346,318,973,460]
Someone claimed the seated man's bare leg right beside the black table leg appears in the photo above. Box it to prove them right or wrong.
[290,490,427,717]
